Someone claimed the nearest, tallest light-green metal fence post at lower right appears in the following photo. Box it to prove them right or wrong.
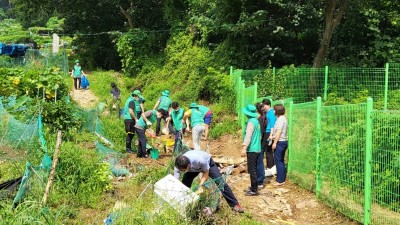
[364,97,373,225]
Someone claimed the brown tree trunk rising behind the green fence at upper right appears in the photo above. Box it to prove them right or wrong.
[308,0,349,99]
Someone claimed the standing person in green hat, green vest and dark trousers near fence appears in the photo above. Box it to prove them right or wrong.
[241,104,261,196]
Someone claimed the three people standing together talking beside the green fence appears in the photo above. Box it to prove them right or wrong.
[241,99,288,196]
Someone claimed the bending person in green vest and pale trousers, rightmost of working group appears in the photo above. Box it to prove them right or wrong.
[183,102,206,150]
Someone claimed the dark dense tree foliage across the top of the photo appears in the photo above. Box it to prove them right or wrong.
[3,0,400,70]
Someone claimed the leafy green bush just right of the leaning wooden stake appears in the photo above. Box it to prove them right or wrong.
[53,140,112,207]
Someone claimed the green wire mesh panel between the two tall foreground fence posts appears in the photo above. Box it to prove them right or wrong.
[318,104,366,221]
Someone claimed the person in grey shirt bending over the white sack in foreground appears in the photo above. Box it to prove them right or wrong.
[174,150,244,213]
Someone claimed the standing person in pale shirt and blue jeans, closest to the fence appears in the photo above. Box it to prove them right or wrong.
[272,104,288,186]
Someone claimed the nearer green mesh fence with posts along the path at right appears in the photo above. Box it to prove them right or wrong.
[288,98,400,225]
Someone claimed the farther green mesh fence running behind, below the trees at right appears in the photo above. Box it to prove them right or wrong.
[234,63,400,109]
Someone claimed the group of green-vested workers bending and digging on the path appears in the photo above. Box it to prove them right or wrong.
[118,87,213,158]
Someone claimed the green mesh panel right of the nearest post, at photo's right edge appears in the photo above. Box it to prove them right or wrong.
[371,111,400,225]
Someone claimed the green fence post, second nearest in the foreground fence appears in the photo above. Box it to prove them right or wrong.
[315,97,322,197]
